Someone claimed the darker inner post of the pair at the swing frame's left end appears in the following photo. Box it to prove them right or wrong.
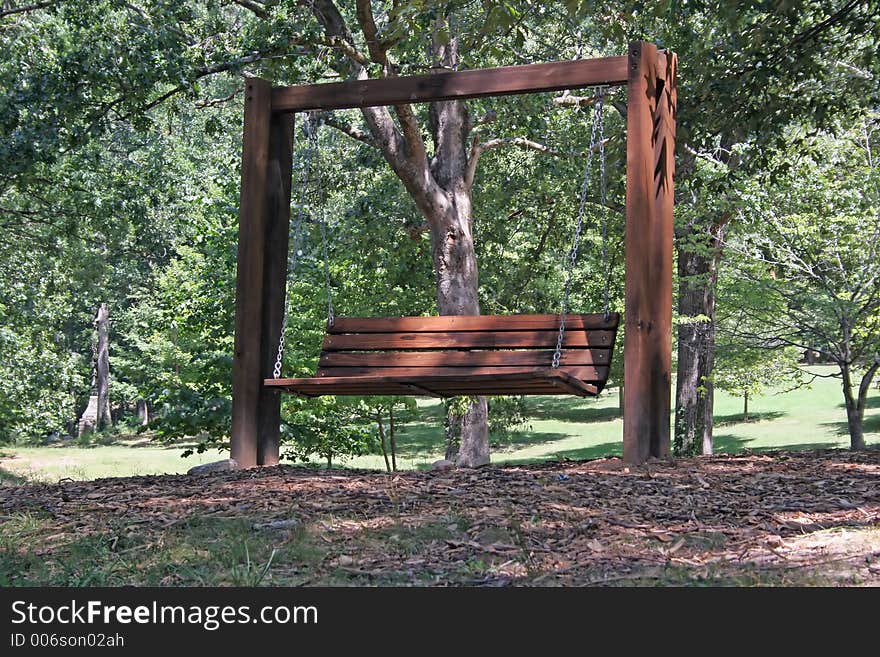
[257,113,293,465]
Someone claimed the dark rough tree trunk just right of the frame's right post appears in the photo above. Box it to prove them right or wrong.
[673,240,717,456]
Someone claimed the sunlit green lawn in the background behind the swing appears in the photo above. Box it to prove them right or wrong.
[0,367,880,481]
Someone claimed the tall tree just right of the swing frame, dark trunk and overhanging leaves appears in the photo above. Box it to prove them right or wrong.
[664,1,878,453]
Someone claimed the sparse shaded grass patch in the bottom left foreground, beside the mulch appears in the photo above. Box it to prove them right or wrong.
[0,514,324,586]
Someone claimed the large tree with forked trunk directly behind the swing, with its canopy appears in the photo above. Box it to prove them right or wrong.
[0,0,619,465]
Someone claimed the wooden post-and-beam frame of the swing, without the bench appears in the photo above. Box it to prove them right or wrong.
[231,41,676,467]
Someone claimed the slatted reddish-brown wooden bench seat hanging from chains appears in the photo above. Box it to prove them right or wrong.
[265,313,620,397]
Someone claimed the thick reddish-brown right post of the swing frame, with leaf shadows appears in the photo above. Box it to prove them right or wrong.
[623,41,676,463]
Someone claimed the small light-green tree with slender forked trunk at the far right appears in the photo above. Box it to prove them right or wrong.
[730,116,880,449]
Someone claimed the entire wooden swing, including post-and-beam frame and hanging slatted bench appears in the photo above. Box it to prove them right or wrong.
[230,41,677,467]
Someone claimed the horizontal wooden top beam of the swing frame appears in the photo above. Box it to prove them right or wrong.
[272,57,628,112]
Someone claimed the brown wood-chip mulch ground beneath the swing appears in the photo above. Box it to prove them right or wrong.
[0,450,880,586]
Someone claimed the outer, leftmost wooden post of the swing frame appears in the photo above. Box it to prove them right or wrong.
[231,78,272,468]
